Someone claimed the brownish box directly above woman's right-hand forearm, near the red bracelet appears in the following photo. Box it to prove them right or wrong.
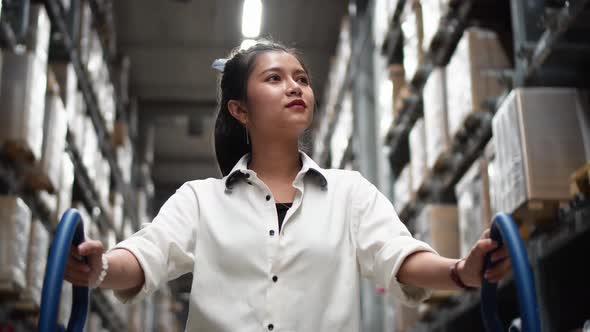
[415,204,460,258]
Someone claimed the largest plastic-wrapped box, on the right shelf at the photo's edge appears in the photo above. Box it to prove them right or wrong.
[492,88,588,213]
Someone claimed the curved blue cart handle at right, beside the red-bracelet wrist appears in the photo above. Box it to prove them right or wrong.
[481,213,541,332]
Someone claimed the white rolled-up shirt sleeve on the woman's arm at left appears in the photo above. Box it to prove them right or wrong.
[111,183,199,303]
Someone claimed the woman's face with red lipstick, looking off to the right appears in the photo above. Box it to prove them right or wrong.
[246,51,315,139]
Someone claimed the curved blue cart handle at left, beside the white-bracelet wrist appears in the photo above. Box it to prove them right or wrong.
[38,209,89,332]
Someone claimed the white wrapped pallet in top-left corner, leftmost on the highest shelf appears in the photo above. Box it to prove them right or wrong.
[26,4,51,66]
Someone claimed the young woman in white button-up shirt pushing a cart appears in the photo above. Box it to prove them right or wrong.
[66,42,510,332]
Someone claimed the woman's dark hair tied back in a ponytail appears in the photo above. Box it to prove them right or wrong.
[214,41,309,176]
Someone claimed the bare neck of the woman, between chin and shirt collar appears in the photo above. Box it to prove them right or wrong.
[248,141,301,181]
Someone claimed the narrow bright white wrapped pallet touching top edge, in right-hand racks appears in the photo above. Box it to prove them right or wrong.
[401,0,424,80]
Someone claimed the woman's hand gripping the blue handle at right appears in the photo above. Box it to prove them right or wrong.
[457,229,512,287]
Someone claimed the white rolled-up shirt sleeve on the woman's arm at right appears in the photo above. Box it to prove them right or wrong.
[352,173,437,305]
